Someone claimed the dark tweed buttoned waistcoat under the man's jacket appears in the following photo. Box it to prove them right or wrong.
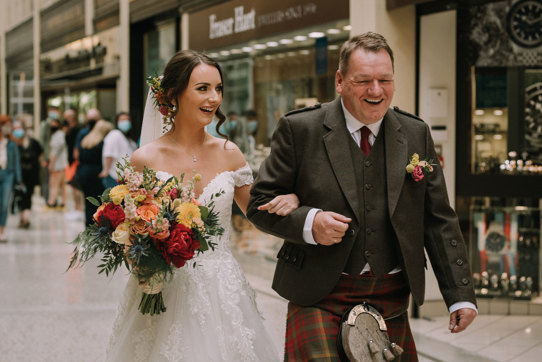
[344,127,399,276]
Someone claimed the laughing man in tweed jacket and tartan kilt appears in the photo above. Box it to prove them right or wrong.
[247,32,476,361]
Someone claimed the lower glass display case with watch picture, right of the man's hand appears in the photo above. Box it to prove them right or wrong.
[470,203,541,300]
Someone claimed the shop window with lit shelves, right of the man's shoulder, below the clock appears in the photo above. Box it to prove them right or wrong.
[470,67,542,175]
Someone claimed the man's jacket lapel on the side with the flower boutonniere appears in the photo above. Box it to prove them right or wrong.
[384,110,408,218]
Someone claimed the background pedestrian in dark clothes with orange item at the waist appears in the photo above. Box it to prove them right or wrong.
[62,109,84,220]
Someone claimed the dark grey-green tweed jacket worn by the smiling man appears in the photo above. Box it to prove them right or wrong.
[247,98,476,306]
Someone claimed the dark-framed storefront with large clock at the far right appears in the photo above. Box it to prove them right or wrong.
[418,0,542,314]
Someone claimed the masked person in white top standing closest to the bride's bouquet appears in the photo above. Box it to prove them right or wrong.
[98,112,137,188]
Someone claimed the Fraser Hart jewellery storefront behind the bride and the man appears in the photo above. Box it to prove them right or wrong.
[188,0,350,168]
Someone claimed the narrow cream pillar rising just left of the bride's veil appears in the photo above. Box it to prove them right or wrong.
[117,0,130,112]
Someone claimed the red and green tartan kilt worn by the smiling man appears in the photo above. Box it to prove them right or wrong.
[284,273,418,361]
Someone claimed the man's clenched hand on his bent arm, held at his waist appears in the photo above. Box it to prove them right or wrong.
[312,211,352,246]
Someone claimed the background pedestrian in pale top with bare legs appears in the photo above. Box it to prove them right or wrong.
[47,119,68,208]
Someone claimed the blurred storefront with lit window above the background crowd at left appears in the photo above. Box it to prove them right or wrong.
[40,0,120,121]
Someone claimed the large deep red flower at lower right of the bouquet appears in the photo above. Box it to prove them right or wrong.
[161,224,200,268]
